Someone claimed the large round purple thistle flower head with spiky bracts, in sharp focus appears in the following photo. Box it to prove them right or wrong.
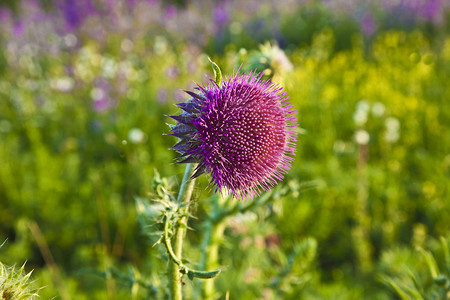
[171,67,297,199]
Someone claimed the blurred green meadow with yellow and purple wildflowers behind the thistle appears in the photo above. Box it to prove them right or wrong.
[0,0,450,300]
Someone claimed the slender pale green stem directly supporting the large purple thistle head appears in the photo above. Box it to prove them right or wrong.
[169,164,195,300]
